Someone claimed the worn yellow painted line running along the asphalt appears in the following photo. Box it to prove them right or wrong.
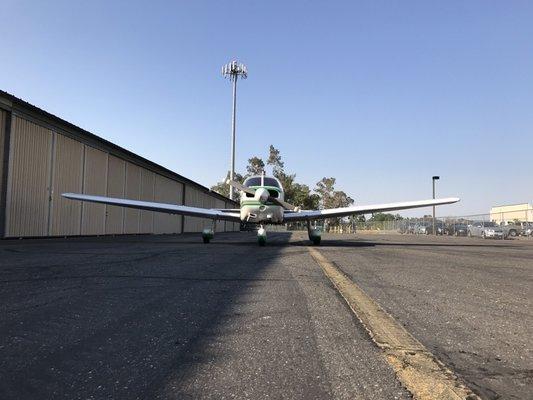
[308,247,480,400]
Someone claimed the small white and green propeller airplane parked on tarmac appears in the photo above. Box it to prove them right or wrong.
[62,174,459,246]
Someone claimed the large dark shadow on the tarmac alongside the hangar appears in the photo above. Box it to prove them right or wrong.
[0,233,291,400]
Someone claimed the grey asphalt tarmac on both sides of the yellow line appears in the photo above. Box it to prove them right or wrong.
[0,232,533,399]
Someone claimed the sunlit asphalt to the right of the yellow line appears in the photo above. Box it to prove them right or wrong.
[320,235,533,399]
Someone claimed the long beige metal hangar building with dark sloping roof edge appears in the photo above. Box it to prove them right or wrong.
[0,91,239,238]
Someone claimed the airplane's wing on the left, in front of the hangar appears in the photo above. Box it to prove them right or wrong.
[62,193,241,222]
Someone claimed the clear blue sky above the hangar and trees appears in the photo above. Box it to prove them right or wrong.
[0,0,533,215]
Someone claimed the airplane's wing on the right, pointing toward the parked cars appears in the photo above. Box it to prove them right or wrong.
[283,197,459,222]
